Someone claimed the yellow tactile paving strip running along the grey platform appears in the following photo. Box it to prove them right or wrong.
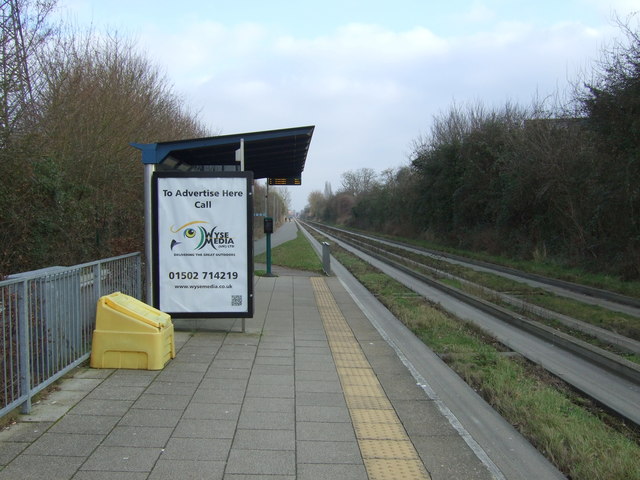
[311,277,431,480]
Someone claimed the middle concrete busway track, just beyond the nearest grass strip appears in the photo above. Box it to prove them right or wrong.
[302,221,640,425]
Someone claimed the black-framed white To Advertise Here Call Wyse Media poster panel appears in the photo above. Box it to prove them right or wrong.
[153,172,253,317]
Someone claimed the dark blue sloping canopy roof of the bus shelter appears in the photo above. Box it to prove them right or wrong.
[131,126,315,178]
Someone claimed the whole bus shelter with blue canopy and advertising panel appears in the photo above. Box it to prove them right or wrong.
[131,126,315,322]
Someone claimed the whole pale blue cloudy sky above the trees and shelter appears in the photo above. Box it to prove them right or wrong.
[59,0,640,210]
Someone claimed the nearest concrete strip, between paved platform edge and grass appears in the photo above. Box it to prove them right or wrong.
[299,225,565,480]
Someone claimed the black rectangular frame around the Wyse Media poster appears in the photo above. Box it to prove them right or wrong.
[151,171,254,318]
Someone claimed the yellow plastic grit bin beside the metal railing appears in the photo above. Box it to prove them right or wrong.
[91,292,176,370]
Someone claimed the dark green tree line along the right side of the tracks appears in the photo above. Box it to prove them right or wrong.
[304,16,640,279]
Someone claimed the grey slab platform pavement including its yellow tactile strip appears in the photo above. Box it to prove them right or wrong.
[0,223,491,480]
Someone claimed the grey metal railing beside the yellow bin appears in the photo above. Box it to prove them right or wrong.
[0,253,142,417]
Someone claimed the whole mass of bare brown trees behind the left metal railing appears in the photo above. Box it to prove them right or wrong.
[0,0,286,278]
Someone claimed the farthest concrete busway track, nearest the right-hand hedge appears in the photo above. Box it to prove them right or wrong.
[317,224,640,318]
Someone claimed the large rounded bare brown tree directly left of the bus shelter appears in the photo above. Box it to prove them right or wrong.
[35,34,206,260]
